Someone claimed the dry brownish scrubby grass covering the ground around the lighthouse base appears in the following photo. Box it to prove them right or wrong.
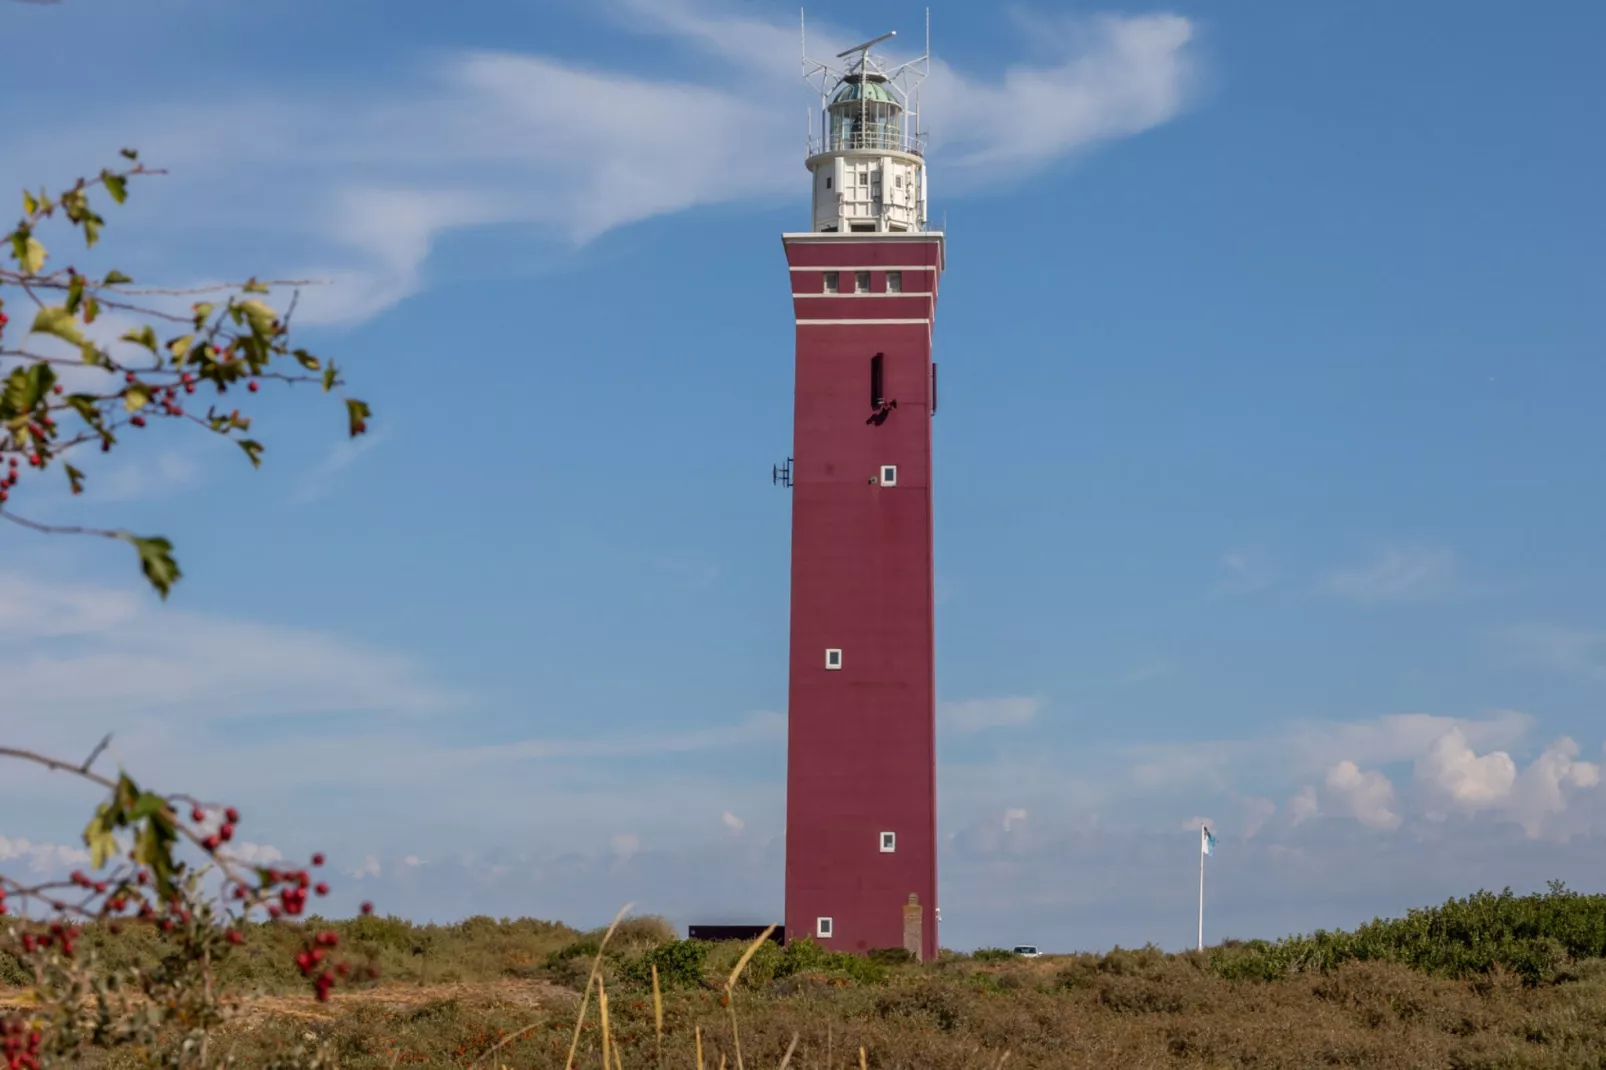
[15,893,1606,1070]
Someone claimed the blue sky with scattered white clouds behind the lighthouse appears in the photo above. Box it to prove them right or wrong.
[0,0,1606,950]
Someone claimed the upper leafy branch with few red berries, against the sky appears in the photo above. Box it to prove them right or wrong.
[0,149,369,598]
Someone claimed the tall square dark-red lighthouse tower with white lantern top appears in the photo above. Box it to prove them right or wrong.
[782,25,943,959]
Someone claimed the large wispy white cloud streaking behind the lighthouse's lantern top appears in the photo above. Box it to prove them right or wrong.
[9,0,1195,323]
